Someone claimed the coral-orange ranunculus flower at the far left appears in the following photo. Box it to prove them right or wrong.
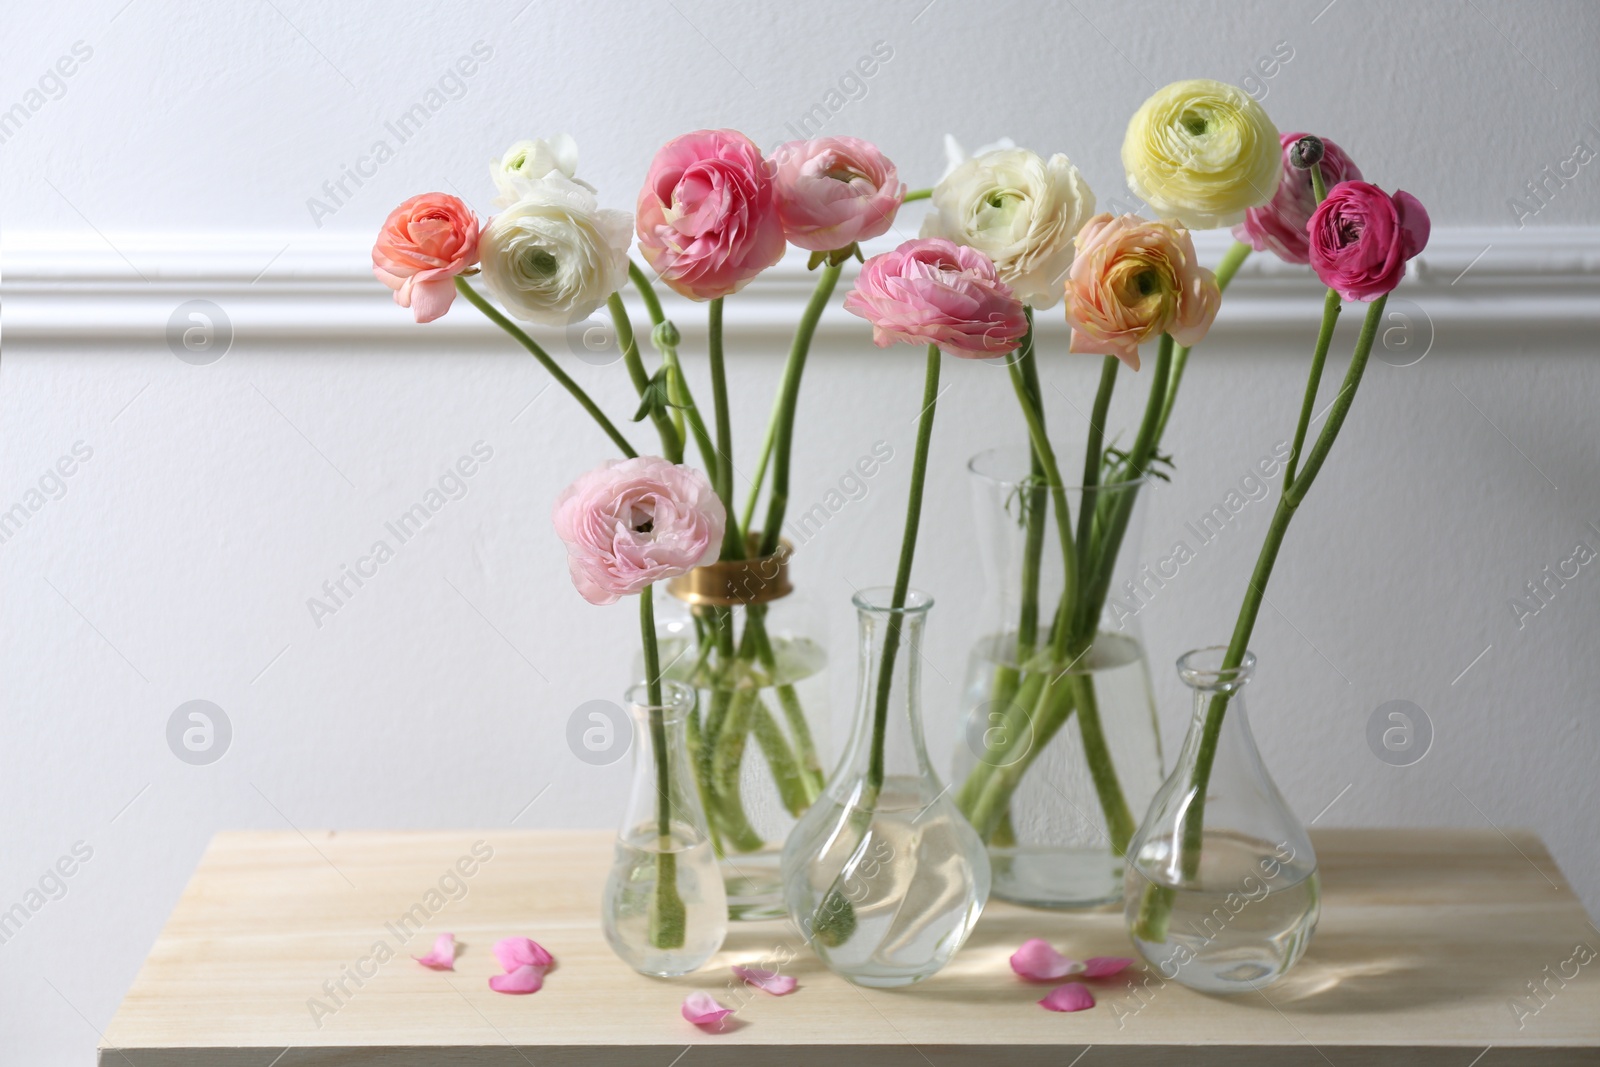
[373,192,478,322]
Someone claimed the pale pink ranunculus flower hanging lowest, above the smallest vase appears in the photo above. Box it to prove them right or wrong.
[552,456,728,605]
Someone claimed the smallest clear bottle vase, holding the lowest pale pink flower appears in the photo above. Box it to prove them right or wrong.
[600,681,728,977]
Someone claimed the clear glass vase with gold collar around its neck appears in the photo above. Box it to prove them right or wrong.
[658,534,827,920]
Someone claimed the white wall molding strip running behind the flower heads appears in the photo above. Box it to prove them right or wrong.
[0,227,1600,347]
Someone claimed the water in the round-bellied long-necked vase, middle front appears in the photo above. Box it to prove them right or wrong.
[789,776,986,987]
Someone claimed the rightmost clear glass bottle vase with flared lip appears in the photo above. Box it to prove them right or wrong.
[1123,646,1320,993]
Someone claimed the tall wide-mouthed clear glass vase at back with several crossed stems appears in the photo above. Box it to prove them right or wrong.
[954,446,1178,909]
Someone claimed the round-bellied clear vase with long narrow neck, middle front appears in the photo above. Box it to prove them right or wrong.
[782,589,989,987]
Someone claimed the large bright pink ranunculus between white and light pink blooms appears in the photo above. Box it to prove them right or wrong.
[635,130,784,301]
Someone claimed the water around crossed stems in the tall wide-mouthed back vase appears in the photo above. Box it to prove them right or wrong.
[955,632,1162,907]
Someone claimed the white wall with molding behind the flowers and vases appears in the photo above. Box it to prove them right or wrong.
[0,0,1600,1062]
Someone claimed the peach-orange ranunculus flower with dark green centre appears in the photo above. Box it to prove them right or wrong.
[1067,214,1222,370]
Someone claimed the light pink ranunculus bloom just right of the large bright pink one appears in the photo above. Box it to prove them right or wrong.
[771,138,906,251]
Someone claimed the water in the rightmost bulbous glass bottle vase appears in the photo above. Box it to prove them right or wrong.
[1126,833,1320,993]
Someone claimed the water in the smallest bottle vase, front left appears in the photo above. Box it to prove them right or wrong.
[600,824,728,977]
